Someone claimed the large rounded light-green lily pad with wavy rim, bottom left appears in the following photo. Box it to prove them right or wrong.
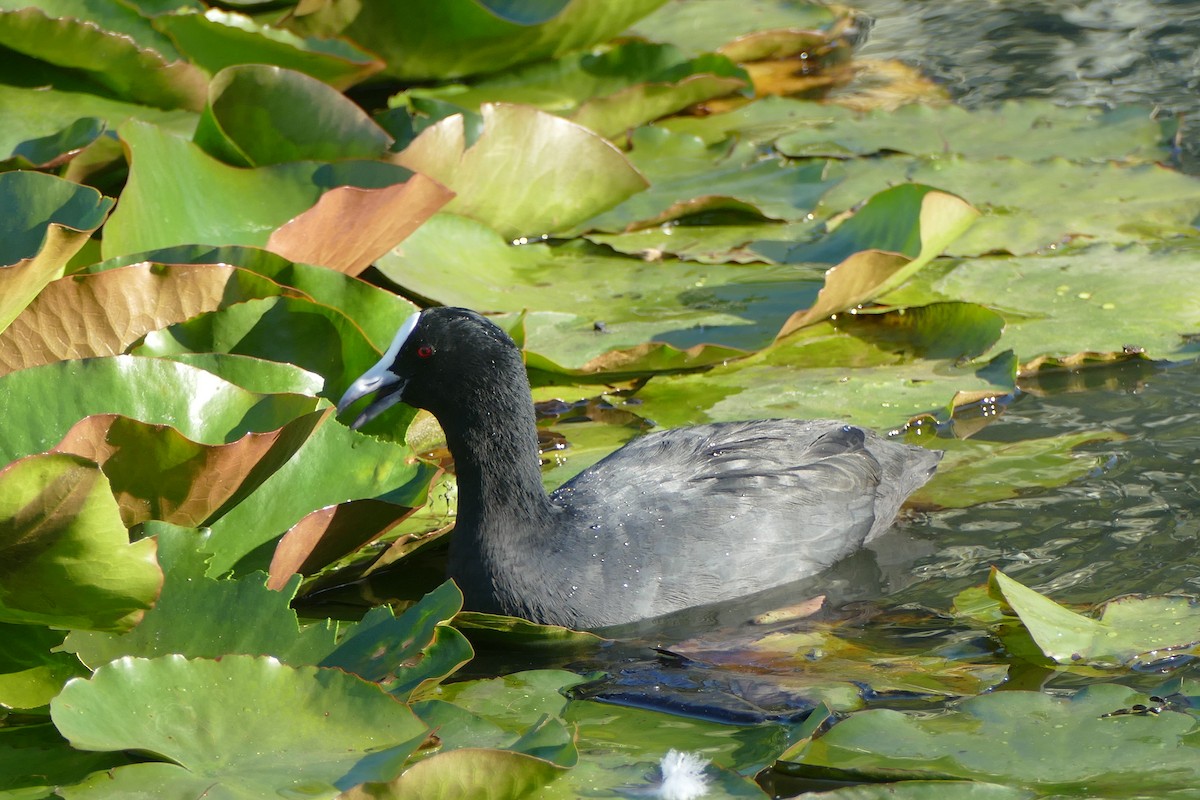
[50,655,426,798]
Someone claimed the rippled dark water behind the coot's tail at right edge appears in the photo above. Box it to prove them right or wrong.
[889,363,1200,608]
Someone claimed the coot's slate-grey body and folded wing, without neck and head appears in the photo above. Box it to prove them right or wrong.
[522,420,940,627]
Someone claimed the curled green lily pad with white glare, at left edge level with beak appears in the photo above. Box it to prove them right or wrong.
[0,355,317,463]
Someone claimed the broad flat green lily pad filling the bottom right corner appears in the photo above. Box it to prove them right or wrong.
[786,684,1200,796]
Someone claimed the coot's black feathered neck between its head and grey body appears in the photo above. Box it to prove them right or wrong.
[442,368,553,610]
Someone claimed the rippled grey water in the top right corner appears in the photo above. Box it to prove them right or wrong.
[850,0,1200,172]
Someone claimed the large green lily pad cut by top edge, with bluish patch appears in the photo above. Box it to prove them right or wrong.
[292,0,662,83]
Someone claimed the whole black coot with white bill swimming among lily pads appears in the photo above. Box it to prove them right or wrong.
[337,308,941,628]
